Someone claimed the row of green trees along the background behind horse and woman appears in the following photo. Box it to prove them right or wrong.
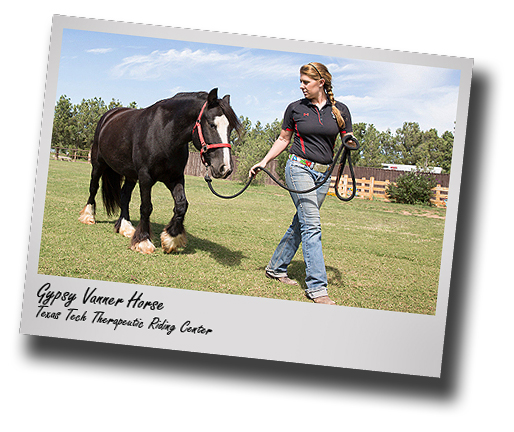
[52,95,453,175]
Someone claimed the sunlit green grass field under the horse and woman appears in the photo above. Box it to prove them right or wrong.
[39,161,445,315]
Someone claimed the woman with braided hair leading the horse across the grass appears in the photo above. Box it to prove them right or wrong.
[249,63,352,305]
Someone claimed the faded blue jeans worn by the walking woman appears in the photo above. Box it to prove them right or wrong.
[266,159,330,299]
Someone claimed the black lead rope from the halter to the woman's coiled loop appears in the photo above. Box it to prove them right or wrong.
[204,135,360,201]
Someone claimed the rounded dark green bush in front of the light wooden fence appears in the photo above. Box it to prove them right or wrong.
[386,171,437,205]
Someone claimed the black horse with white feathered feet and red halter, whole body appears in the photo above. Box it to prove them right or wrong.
[79,89,241,253]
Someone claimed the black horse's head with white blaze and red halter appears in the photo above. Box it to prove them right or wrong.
[193,88,240,178]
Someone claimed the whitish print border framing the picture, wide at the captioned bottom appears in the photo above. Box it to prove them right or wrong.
[20,15,473,377]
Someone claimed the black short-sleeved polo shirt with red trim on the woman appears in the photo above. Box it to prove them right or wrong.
[282,99,353,164]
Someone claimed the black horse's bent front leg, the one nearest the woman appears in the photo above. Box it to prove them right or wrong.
[161,177,188,253]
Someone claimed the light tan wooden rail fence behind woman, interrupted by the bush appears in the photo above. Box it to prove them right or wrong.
[328,174,448,207]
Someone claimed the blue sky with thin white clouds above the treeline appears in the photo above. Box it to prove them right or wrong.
[56,29,460,135]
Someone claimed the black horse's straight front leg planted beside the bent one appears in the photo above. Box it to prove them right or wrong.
[130,173,155,254]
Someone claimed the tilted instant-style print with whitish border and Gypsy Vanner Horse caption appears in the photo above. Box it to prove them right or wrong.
[22,16,472,376]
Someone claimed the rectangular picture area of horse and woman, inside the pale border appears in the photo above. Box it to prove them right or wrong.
[38,25,460,315]
